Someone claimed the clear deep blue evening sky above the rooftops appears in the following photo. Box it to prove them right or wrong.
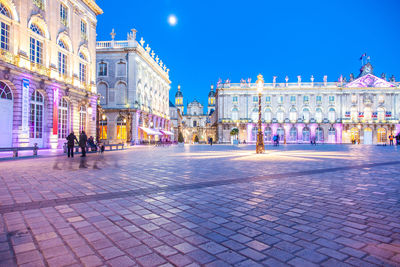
[97,0,400,110]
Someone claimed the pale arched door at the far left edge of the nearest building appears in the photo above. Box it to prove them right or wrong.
[0,82,13,147]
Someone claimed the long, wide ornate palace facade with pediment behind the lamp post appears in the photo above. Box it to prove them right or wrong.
[217,62,400,144]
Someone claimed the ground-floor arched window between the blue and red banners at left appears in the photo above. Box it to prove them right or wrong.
[29,91,44,139]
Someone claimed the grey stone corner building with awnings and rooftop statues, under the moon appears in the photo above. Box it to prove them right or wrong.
[96,30,173,144]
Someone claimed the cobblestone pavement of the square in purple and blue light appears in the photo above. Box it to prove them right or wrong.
[0,145,400,267]
